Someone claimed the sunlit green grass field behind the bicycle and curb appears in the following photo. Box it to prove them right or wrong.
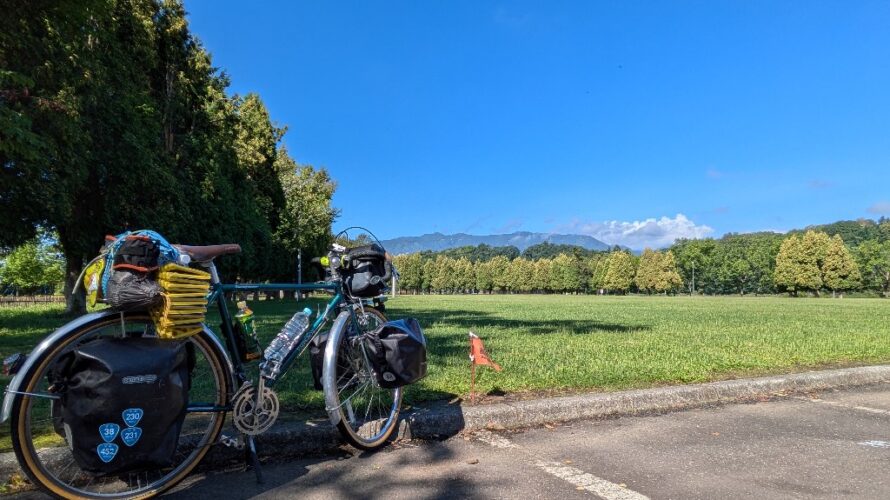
[0,295,890,454]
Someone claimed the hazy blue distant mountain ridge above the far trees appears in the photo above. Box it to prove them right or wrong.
[381,231,611,255]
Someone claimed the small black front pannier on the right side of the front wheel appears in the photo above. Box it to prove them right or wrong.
[364,318,426,389]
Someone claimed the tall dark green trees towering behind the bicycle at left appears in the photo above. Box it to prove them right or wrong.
[0,0,337,311]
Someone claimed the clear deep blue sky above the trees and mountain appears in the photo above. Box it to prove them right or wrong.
[185,0,890,248]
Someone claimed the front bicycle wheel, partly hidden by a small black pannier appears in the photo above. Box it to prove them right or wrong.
[322,307,402,450]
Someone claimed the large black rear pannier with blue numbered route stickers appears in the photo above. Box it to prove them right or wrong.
[49,337,194,476]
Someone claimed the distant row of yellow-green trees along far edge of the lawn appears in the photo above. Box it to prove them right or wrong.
[394,219,890,295]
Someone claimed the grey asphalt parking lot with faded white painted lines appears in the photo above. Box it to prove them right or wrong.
[8,385,890,500]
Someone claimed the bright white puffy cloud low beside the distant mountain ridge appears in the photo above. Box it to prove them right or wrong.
[558,214,714,250]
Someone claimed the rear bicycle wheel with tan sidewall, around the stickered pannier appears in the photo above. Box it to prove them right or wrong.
[11,312,232,499]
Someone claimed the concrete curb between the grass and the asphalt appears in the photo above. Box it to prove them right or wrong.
[0,365,890,479]
